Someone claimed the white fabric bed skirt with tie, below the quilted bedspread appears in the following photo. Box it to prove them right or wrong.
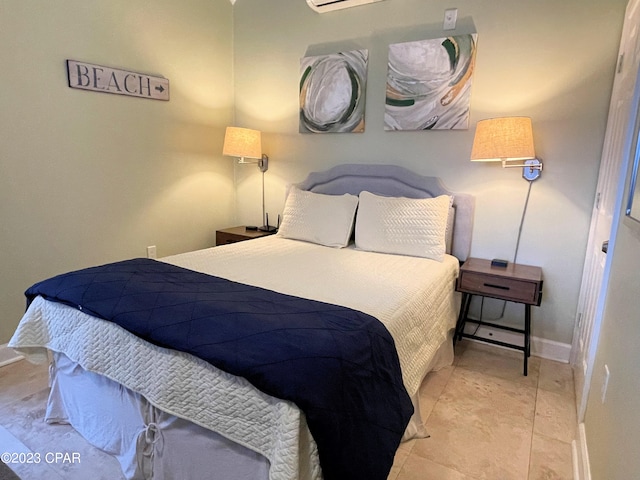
[45,352,269,480]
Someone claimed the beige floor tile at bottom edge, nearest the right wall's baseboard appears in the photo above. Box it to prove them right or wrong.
[529,435,573,480]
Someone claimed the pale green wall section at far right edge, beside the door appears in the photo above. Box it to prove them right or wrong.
[584,205,640,480]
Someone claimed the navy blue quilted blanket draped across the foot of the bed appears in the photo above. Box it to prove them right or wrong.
[25,259,413,480]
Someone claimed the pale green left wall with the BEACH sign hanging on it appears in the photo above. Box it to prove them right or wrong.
[0,0,234,344]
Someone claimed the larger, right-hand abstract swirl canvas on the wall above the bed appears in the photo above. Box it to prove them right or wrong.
[384,33,478,130]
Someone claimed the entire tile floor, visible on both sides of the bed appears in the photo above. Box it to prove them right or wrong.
[0,341,576,480]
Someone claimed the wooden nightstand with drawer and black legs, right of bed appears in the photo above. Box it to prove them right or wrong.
[454,258,542,376]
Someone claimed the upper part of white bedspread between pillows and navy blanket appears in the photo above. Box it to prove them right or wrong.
[163,236,459,396]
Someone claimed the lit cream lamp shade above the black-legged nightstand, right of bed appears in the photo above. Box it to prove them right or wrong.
[471,117,536,162]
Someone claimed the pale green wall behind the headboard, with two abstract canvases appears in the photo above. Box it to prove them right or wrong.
[234,0,626,344]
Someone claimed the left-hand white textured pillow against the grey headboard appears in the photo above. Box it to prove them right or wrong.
[278,187,358,248]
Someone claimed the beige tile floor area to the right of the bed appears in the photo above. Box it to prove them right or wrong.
[389,341,576,480]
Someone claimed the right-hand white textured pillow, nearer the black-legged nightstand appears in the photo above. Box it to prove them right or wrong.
[356,192,453,262]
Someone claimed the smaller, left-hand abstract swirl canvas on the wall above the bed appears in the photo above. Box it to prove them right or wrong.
[300,50,369,133]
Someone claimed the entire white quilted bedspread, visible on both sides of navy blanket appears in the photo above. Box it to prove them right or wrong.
[9,236,458,480]
